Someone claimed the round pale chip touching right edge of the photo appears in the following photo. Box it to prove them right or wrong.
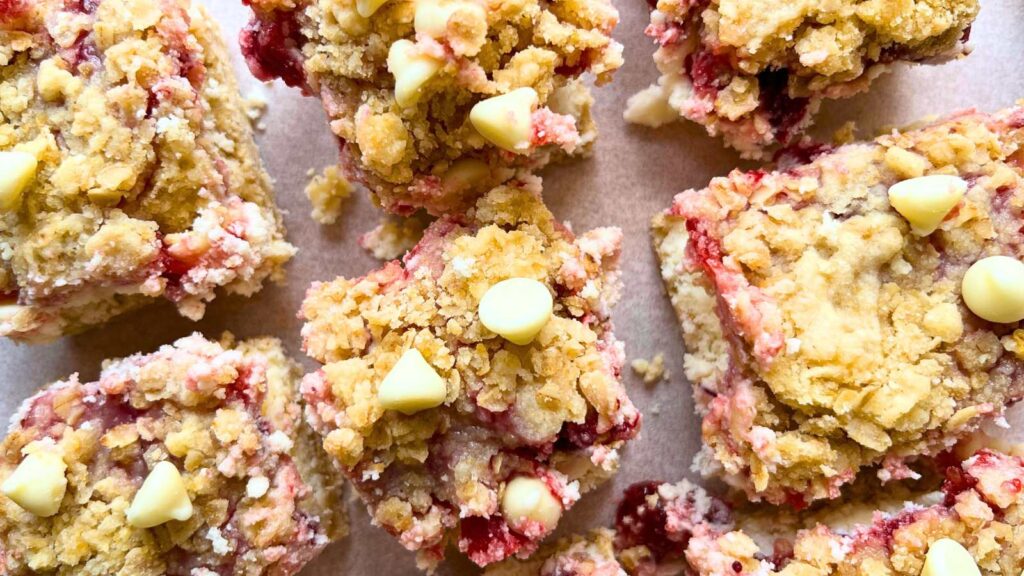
[961,256,1024,324]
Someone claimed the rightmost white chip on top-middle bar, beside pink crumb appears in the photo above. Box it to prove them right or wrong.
[469,88,539,154]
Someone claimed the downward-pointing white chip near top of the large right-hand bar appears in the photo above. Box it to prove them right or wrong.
[889,174,968,236]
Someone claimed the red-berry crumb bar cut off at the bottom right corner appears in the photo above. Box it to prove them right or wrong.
[615,450,1024,576]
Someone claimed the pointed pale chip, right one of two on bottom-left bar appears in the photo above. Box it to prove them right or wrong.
[127,461,193,528]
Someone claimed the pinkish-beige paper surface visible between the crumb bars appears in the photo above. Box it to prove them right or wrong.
[0,0,1024,576]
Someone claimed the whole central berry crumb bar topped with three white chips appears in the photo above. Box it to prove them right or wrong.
[301,177,640,568]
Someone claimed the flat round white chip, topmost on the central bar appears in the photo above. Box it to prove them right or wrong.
[479,278,554,345]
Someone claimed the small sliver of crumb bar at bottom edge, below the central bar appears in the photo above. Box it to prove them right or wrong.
[483,528,626,576]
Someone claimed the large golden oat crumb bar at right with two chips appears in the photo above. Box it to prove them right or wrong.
[654,108,1024,506]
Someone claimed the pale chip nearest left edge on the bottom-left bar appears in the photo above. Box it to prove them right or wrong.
[2,452,68,518]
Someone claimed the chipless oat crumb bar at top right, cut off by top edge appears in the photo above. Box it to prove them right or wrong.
[626,0,979,158]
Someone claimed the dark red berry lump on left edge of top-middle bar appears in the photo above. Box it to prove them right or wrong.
[239,12,310,95]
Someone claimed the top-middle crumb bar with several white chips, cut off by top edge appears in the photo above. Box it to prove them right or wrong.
[242,0,623,214]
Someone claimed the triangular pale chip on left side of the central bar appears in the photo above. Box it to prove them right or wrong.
[377,348,447,414]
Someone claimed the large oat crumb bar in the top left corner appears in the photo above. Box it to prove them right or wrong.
[0,0,294,341]
